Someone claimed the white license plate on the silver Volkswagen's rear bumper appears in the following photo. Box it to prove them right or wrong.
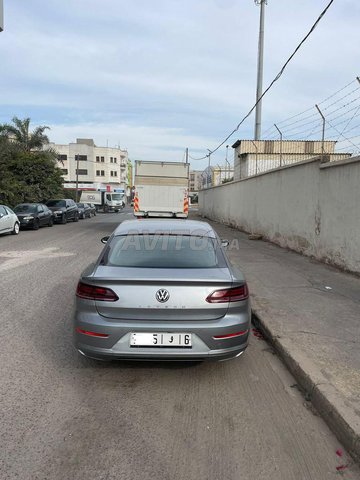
[130,333,191,348]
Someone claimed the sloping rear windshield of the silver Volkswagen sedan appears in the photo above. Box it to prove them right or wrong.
[101,234,226,268]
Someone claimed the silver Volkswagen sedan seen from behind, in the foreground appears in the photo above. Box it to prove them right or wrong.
[74,219,251,361]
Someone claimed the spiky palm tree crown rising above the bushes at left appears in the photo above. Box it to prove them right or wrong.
[0,117,50,152]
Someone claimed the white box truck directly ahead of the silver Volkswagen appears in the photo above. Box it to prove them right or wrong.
[133,160,189,218]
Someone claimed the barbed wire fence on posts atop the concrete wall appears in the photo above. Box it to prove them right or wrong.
[202,77,360,188]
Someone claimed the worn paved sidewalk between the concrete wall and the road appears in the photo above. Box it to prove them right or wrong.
[190,211,360,461]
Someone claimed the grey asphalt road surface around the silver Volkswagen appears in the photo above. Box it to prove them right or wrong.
[0,210,360,480]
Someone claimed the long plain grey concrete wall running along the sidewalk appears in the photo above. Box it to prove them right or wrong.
[199,157,360,273]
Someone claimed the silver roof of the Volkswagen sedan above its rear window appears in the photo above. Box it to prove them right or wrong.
[114,218,216,238]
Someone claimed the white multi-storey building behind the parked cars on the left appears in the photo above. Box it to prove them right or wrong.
[49,138,129,192]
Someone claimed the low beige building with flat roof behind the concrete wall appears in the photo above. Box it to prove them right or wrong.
[232,140,351,180]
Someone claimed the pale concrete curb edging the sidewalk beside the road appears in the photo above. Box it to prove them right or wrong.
[252,299,360,463]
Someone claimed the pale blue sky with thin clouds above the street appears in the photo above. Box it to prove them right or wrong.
[0,0,360,169]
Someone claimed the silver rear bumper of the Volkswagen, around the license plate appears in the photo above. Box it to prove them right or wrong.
[74,311,250,361]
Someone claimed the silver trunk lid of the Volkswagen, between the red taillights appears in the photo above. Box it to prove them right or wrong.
[87,266,232,321]
